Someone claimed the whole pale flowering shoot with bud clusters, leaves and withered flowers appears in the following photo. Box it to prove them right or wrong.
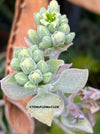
[1,0,100,133]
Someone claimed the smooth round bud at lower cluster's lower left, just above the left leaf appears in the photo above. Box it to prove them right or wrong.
[15,72,28,86]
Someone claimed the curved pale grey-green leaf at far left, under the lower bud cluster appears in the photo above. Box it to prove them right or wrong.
[1,74,36,100]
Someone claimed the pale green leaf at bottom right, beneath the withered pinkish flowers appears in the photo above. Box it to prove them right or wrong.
[61,115,93,133]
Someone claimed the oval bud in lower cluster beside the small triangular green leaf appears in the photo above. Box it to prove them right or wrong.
[37,60,48,74]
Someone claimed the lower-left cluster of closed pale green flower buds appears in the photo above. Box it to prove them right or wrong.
[11,45,52,89]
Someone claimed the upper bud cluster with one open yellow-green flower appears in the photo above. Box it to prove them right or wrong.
[28,0,75,49]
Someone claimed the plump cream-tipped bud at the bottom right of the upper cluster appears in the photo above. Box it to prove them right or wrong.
[51,31,65,47]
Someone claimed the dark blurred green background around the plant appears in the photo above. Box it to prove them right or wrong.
[0,0,100,134]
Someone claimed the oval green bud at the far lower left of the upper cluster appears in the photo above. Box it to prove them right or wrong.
[28,29,40,44]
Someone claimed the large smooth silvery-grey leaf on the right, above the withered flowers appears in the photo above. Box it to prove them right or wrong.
[53,68,88,93]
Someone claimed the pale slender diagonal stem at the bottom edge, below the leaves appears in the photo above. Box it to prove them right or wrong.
[53,118,75,134]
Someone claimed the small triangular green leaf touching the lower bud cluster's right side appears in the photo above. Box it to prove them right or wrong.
[47,60,63,74]
